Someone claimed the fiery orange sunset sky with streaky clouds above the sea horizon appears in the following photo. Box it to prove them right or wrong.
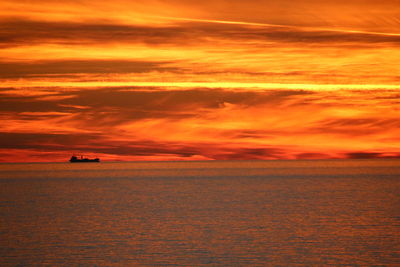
[0,0,400,162]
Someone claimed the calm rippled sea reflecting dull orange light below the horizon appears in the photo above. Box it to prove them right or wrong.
[0,160,400,266]
